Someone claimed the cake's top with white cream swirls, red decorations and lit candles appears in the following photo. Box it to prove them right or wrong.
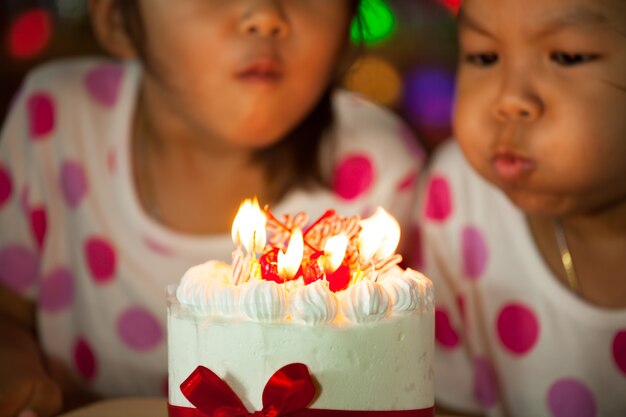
[176,199,433,324]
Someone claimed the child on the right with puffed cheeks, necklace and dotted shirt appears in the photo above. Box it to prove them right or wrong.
[414,0,626,417]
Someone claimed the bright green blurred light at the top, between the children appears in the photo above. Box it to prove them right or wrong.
[351,0,396,45]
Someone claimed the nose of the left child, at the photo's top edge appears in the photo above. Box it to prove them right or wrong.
[239,0,289,39]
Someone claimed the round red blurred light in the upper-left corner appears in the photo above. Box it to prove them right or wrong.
[8,8,52,59]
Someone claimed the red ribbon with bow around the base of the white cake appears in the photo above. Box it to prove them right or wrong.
[168,363,435,417]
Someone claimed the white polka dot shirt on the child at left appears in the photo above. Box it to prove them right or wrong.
[0,59,422,396]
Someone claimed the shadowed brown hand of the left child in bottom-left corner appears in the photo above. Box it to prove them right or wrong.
[0,355,63,417]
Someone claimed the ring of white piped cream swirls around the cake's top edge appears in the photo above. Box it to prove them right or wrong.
[176,261,434,325]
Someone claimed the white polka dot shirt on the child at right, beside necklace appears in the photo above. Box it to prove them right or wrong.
[418,142,626,417]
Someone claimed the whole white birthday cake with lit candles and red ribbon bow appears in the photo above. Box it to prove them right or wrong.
[168,200,434,417]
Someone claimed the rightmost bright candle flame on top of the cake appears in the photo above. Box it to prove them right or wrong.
[359,207,400,262]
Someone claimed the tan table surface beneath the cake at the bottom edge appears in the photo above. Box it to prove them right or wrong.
[59,398,454,417]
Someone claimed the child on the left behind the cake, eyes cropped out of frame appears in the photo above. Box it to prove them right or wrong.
[0,0,420,417]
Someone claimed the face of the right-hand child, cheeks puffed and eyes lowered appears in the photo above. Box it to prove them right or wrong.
[454,0,626,215]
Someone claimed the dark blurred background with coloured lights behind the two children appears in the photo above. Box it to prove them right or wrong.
[0,0,461,150]
